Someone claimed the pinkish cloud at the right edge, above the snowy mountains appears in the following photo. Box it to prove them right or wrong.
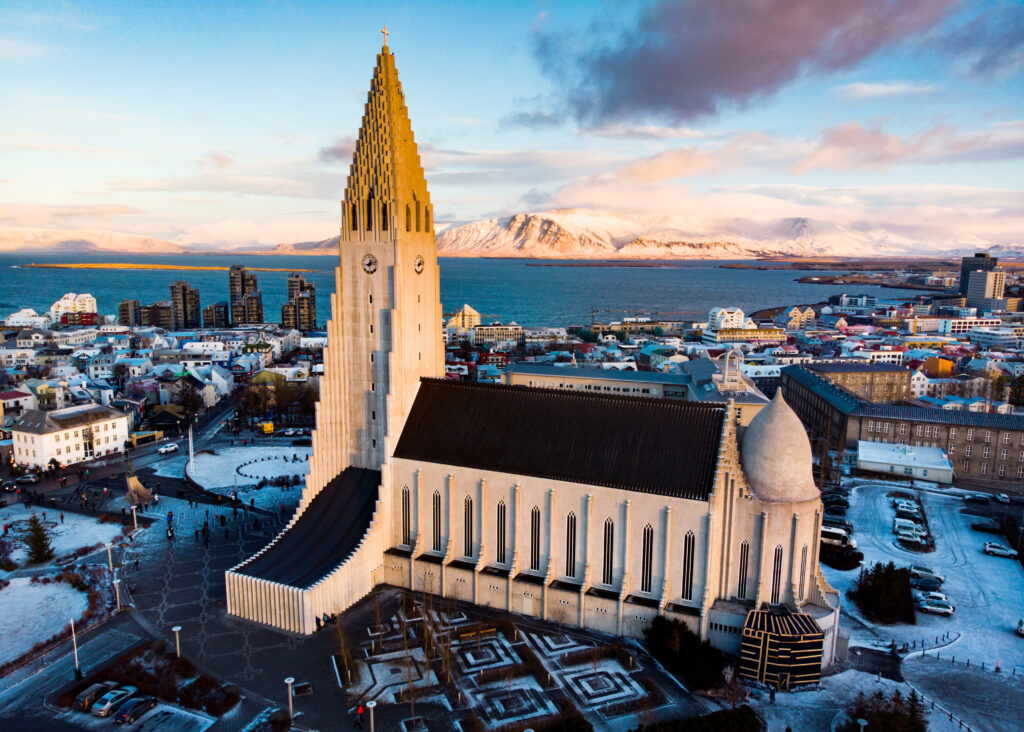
[792,121,1024,175]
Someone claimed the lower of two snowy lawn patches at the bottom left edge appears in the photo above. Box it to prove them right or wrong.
[0,577,89,663]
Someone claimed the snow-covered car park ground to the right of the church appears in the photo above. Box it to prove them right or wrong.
[822,484,1024,674]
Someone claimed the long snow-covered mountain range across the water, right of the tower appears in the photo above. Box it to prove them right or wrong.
[437,209,1013,259]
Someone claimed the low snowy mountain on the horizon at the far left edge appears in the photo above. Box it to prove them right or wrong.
[0,226,187,254]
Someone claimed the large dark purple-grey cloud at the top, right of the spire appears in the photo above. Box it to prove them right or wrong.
[534,0,955,124]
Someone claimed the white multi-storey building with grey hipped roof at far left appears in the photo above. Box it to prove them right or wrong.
[10,404,128,469]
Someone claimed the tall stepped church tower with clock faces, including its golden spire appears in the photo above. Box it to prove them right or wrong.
[308,36,444,492]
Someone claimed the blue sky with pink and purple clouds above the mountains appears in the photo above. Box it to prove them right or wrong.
[0,0,1024,248]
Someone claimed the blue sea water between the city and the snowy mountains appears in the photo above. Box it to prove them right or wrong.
[0,254,921,326]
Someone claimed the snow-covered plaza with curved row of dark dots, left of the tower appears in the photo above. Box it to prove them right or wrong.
[180,445,312,492]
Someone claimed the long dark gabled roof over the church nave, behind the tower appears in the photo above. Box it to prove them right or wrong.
[394,379,725,501]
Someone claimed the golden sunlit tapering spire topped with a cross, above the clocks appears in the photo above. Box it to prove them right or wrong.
[341,42,433,242]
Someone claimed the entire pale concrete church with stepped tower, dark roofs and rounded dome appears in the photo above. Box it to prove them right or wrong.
[226,38,840,673]
